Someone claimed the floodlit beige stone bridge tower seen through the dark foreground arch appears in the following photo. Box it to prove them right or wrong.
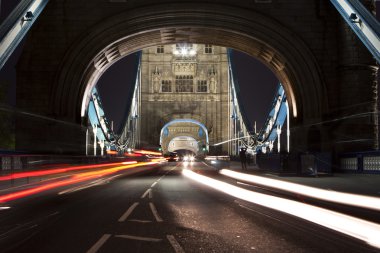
[140,43,231,154]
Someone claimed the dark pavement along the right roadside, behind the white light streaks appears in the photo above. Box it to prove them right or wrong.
[229,161,380,197]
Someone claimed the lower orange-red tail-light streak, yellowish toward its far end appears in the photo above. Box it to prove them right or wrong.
[0,162,156,203]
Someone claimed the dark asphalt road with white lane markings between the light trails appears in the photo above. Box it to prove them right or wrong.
[0,163,377,253]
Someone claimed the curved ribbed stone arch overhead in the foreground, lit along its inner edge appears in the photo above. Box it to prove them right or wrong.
[52,3,327,122]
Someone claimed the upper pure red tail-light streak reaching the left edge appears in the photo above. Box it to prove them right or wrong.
[0,162,129,181]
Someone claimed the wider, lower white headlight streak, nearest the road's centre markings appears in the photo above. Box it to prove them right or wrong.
[182,169,380,248]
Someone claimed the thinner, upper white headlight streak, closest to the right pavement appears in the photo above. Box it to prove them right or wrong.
[219,169,380,210]
